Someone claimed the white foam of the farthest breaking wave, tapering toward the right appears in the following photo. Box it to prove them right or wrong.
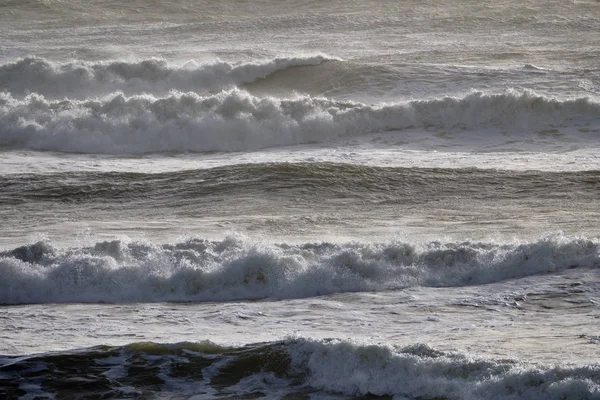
[0,55,333,99]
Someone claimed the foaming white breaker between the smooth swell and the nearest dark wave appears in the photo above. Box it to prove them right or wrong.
[0,237,600,304]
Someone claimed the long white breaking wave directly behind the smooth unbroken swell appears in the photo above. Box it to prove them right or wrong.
[0,89,600,154]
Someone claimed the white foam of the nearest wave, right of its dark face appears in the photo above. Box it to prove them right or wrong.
[290,340,600,399]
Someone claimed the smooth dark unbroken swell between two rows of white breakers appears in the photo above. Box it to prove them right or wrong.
[0,162,600,207]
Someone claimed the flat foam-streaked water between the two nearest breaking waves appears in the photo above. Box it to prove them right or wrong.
[0,269,600,368]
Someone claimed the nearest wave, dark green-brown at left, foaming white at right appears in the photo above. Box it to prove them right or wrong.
[0,339,600,400]
